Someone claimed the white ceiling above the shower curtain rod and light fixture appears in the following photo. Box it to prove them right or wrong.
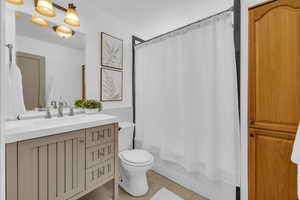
[53,0,233,39]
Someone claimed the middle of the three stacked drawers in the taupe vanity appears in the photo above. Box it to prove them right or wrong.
[86,142,114,168]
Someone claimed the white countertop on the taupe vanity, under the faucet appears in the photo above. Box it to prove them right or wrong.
[5,114,119,143]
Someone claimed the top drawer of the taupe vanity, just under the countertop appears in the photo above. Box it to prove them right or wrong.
[86,125,114,147]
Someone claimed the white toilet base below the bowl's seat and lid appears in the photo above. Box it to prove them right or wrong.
[120,166,149,197]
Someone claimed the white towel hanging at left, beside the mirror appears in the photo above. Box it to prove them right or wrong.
[6,64,25,118]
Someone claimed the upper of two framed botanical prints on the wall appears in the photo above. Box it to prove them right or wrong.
[101,32,123,69]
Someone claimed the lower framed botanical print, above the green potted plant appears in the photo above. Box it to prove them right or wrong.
[100,67,123,101]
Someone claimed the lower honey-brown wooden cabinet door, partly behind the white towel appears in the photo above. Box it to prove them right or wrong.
[249,129,297,200]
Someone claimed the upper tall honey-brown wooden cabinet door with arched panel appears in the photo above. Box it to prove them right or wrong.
[249,0,300,132]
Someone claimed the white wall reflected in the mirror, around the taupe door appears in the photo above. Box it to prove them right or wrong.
[16,35,85,104]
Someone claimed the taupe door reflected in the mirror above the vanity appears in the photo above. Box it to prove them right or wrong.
[17,52,46,110]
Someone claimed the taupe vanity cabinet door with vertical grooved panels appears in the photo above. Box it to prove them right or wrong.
[18,131,85,200]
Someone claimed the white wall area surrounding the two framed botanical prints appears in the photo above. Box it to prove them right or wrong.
[86,17,134,108]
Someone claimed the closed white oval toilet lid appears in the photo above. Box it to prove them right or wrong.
[120,149,153,164]
